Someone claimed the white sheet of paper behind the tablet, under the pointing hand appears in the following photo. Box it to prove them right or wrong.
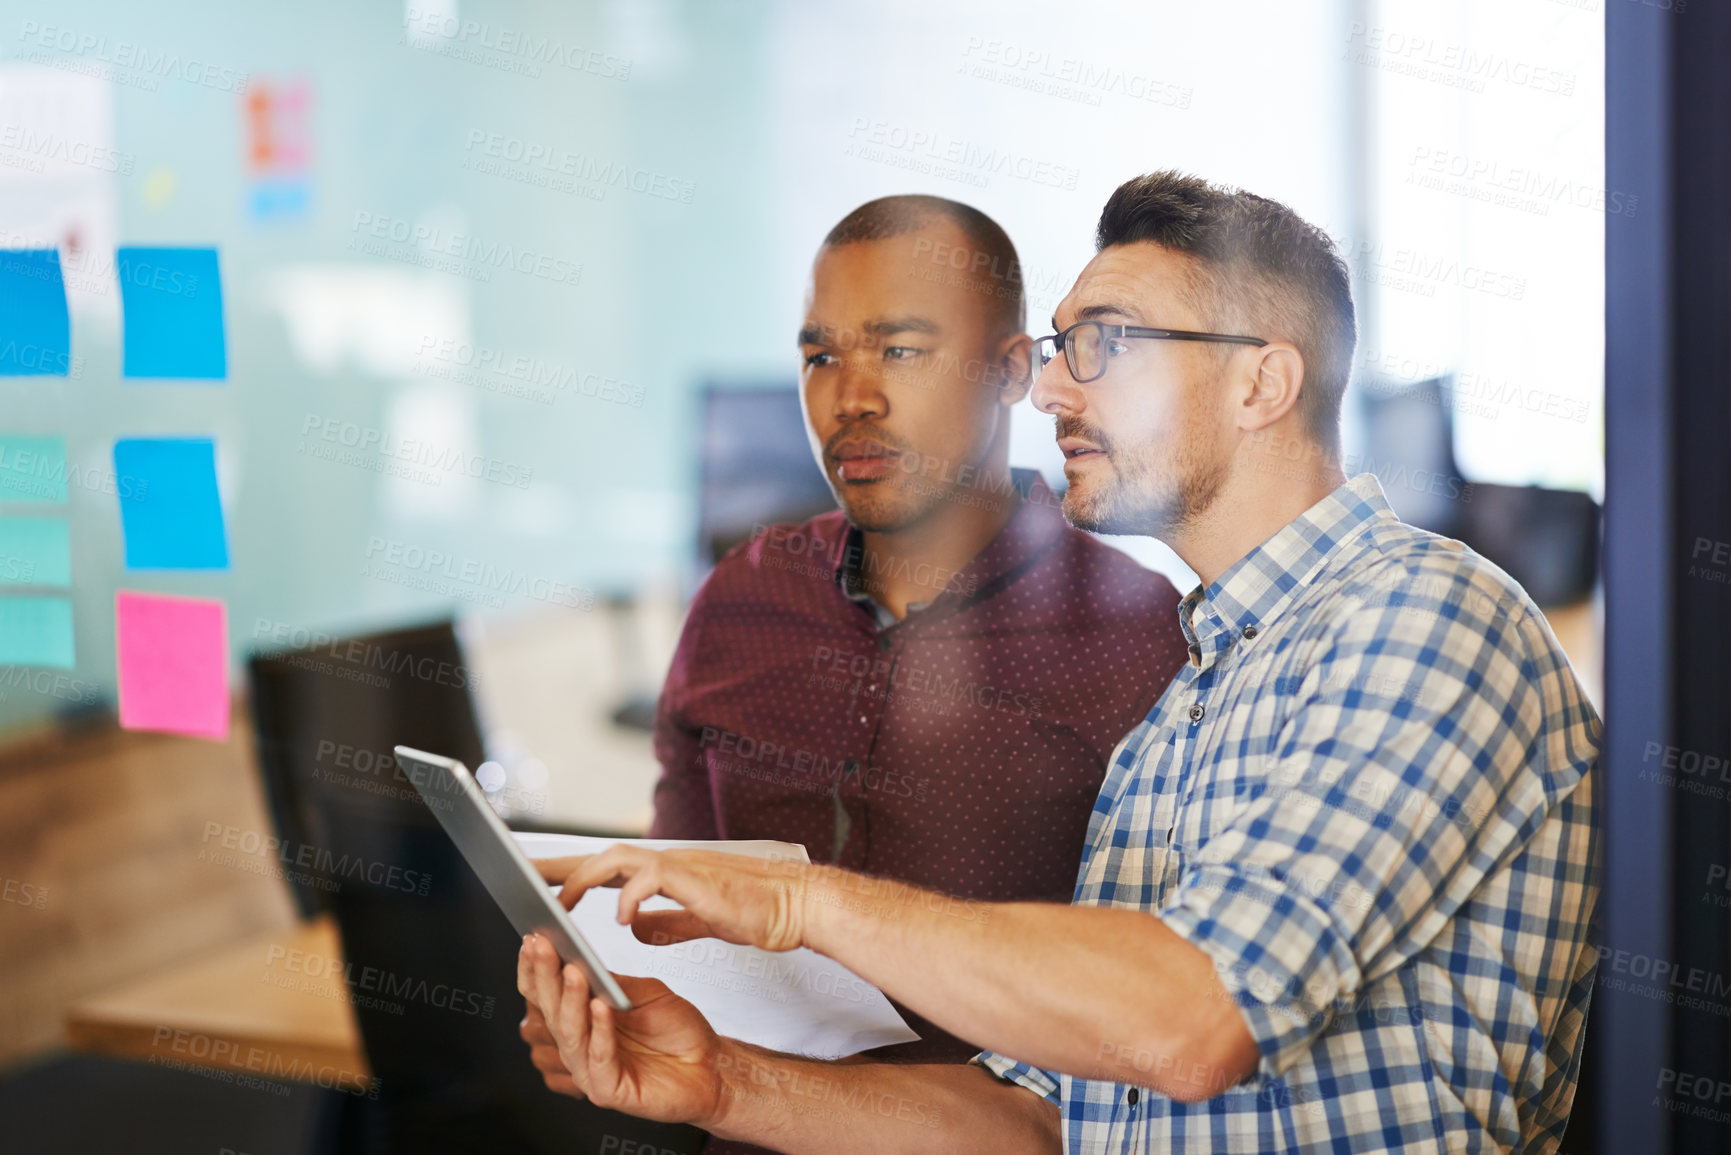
[516,835,919,1058]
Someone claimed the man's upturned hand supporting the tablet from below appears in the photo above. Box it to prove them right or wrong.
[518,935,724,1126]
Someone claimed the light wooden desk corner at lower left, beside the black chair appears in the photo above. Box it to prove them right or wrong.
[66,918,372,1091]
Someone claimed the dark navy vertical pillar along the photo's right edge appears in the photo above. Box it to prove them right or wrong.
[1599,0,1731,1153]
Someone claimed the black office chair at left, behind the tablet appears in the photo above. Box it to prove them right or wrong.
[248,622,703,1155]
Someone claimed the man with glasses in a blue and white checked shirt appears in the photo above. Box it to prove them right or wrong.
[519,173,1601,1155]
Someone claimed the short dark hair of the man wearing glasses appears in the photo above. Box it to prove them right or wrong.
[1094,170,1359,448]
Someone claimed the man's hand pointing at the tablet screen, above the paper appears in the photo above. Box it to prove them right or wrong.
[535,847,815,951]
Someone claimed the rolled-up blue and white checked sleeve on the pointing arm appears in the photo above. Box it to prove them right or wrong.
[1160,577,1580,1079]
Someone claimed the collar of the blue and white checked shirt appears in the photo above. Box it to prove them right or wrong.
[1179,473,1395,668]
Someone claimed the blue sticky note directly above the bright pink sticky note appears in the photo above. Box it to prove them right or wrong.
[114,438,228,570]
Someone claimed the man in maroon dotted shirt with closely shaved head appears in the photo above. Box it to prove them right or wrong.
[649,196,1186,1087]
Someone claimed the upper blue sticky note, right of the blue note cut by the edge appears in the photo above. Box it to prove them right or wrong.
[114,246,228,381]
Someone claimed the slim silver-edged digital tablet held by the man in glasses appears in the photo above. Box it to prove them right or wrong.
[396,746,632,1011]
